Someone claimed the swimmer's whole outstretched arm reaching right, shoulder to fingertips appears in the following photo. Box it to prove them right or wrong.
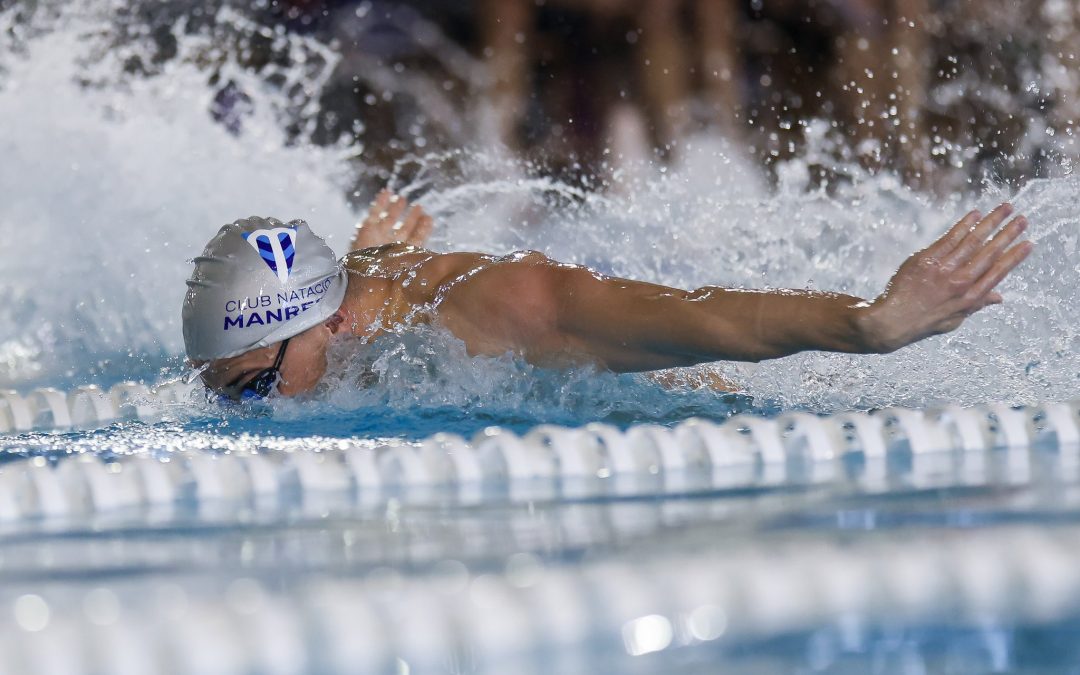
[451,204,1032,372]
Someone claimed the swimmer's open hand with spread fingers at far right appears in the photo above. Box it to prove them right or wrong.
[861,204,1035,353]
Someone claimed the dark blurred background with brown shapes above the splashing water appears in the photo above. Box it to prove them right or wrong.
[50,0,1080,195]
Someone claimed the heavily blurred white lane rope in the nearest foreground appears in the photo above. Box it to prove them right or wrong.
[0,527,1080,675]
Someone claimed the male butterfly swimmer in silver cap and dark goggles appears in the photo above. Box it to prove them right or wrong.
[183,191,1034,401]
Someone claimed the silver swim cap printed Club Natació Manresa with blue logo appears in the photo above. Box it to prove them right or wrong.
[183,217,347,361]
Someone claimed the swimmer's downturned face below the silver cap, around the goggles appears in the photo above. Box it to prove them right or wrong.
[202,313,343,396]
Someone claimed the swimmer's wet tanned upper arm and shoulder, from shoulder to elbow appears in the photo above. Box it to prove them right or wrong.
[438,258,743,372]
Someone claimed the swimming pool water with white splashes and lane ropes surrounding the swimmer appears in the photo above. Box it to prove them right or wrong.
[0,3,1080,674]
